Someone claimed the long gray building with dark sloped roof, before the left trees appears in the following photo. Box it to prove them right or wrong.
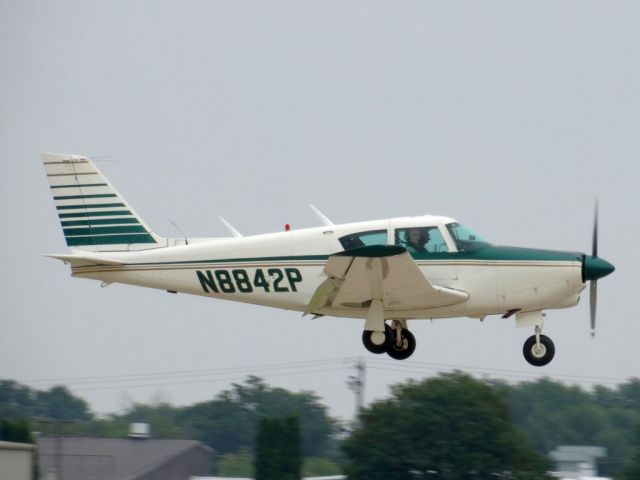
[37,436,213,480]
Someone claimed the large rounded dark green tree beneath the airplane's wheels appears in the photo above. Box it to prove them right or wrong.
[344,373,547,480]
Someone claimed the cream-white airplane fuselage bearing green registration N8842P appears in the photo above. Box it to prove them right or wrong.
[63,216,585,319]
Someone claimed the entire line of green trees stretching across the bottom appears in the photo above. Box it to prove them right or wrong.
[0,373,640,479]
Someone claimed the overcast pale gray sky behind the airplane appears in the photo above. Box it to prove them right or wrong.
[0,0,640,418]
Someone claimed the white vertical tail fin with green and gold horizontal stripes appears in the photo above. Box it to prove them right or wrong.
[42,153,164,252]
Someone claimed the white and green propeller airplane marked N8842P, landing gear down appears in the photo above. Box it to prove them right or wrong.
[42,153,615,367]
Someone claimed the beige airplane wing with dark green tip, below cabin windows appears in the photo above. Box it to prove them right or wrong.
[305,245,469,314]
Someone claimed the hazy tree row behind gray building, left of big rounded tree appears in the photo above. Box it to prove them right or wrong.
[0,376,336,457]
